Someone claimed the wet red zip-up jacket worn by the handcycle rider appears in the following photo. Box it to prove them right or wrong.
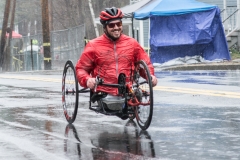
[76,34,154,95]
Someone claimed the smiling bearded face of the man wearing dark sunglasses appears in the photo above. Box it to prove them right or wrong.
[106,20,122,39]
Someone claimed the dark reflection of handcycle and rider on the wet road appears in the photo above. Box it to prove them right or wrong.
[64,120,155,160]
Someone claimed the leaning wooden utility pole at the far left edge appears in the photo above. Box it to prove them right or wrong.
[0,0,10,72]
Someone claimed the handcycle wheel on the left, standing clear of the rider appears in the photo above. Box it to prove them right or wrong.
[62,60,79,124]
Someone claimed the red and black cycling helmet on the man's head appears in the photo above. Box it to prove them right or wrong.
[100,7,123,27]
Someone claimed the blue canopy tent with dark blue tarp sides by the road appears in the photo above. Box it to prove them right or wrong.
[134,0,230,63]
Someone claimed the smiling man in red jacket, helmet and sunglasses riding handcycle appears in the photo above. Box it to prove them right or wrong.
[76,7,157,96]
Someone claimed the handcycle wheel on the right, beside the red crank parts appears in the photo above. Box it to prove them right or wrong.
[134,60,153,130]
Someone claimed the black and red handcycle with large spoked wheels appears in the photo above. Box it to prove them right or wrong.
[62,60,153,130]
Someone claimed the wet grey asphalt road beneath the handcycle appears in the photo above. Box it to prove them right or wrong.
[0,71,240,160]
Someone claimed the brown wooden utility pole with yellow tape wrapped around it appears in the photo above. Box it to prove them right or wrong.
[41,0,52,70]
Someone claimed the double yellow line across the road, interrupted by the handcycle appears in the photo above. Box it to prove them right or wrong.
[0,75,240,99]
